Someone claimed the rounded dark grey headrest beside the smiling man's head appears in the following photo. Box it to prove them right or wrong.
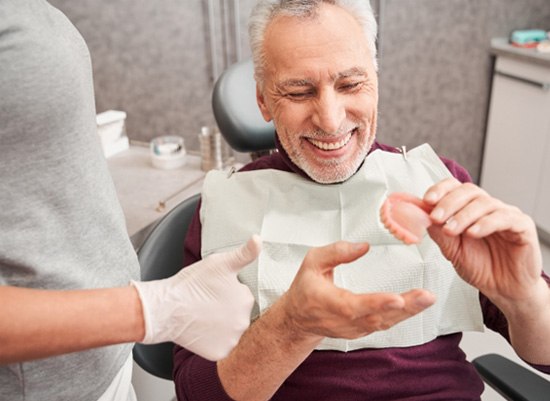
[212,60,275,152]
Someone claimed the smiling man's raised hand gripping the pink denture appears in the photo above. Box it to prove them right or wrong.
[424,179,546,305]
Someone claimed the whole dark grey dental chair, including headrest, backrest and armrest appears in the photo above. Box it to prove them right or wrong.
[133,61,550,401]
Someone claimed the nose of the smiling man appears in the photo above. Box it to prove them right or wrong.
[312,90,346,134]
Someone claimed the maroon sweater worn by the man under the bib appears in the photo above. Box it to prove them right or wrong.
[174,139,550,401]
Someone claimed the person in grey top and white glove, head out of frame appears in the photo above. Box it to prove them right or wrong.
[0,0,260,401]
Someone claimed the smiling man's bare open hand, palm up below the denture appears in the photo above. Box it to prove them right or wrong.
[281,241,435,340]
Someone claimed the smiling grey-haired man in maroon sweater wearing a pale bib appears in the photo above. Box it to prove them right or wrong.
[174,0,550,401]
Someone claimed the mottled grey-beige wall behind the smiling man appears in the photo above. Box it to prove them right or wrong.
[51,0,550,179]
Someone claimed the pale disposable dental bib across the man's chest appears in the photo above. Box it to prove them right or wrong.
[200,144,483,351]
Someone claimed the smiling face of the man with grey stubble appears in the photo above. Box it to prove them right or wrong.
[257,4,378,183]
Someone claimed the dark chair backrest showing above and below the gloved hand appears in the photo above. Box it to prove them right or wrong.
[133,194,200,380]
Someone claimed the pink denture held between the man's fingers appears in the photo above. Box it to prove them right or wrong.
[380,192,432,244]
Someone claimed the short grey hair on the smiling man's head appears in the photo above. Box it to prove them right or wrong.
[248,0,378,86]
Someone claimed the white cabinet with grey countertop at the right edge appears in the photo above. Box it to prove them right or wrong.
[480,39,550,242]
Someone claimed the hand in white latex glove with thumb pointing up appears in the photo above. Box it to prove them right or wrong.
[132,235,261,361]
